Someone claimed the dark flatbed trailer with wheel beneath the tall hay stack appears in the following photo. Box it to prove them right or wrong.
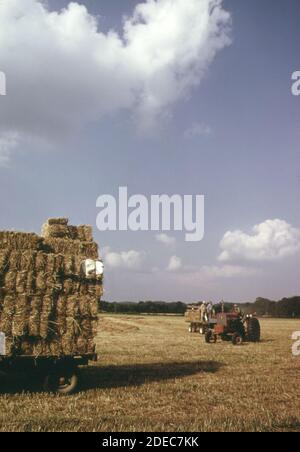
[0,354,98,395]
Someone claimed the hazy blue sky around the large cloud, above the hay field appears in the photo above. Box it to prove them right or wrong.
[0,0,300,301]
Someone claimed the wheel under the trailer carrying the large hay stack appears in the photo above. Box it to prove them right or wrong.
[44,369,79,395]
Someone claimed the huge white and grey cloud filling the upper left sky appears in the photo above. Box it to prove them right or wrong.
[0,0,231,162]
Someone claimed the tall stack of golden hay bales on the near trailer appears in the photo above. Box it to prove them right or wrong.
[0,218,103,357]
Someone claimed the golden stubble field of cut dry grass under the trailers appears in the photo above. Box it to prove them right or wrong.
[0,316,300,432]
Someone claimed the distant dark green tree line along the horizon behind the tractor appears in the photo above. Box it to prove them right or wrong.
[99,296,300,318]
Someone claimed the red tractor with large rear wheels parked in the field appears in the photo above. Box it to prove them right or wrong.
[205,312,261,345]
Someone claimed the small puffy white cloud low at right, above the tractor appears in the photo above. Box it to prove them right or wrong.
[219,219,300,261]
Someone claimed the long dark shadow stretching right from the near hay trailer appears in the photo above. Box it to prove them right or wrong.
[81,361,222,391]
